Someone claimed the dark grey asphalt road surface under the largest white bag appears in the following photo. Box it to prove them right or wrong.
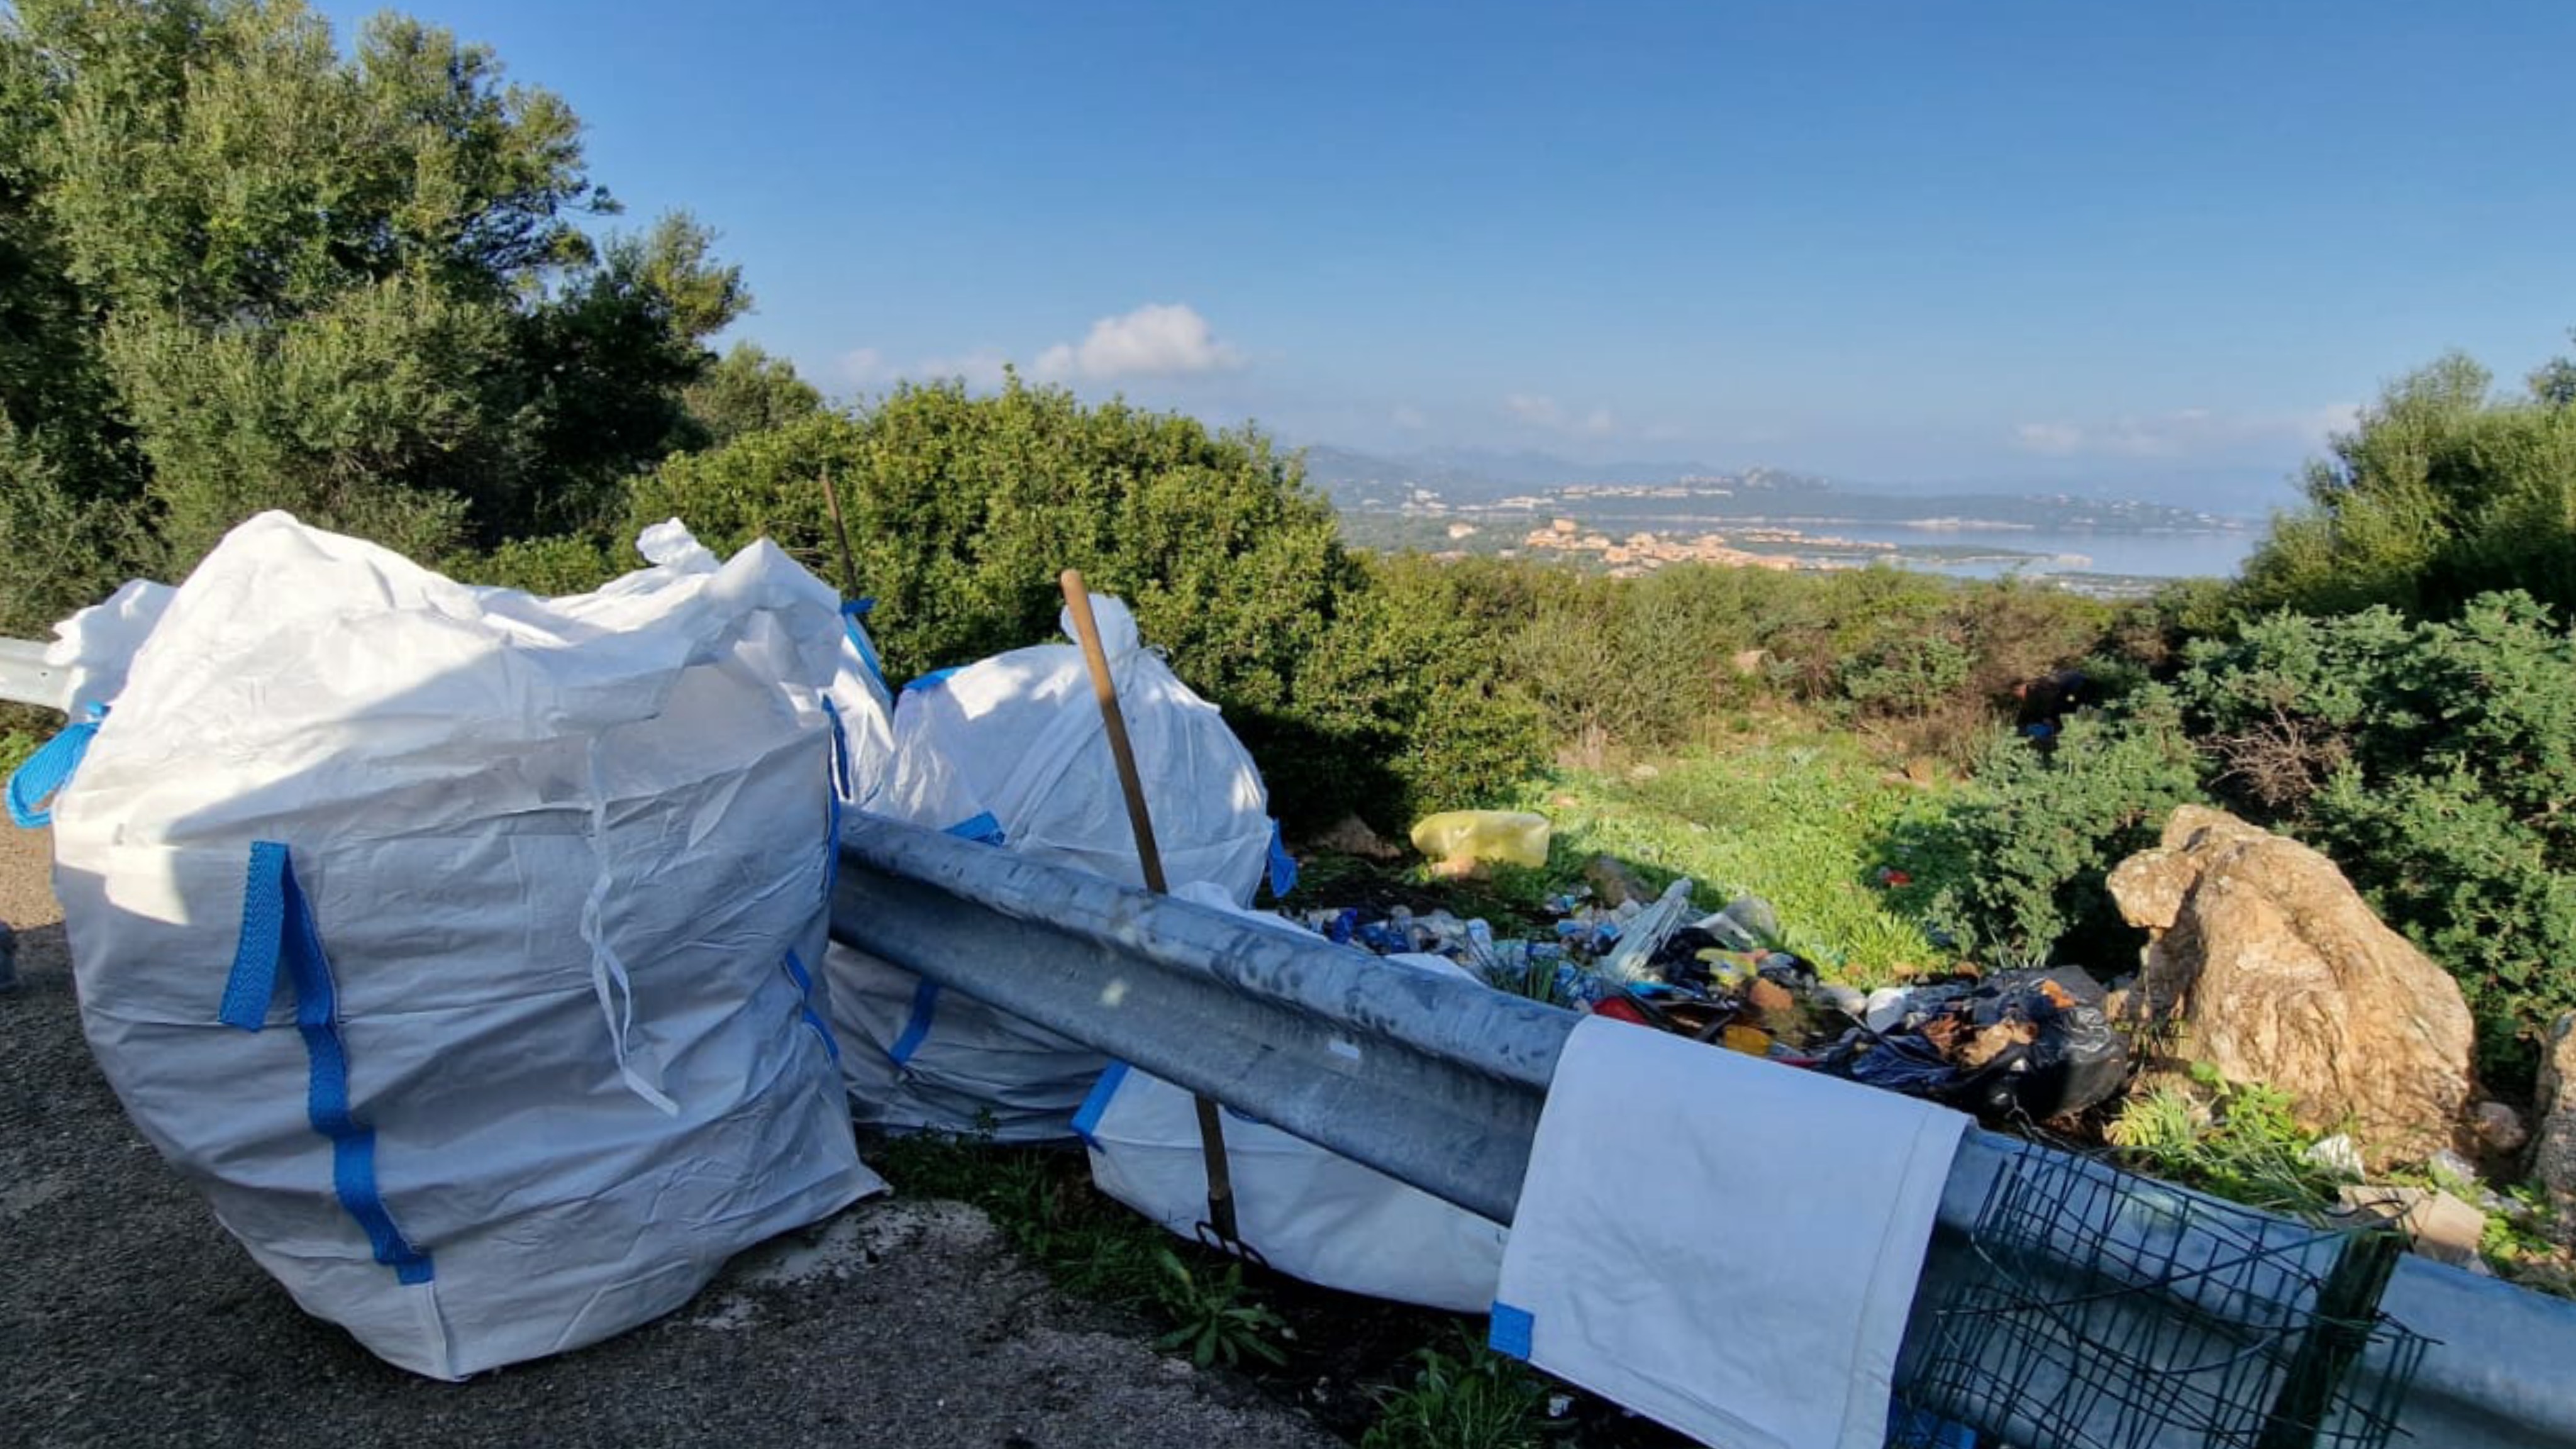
[0,825,1335,1449]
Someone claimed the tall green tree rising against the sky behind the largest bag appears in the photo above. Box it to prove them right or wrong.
[0,0,747,626]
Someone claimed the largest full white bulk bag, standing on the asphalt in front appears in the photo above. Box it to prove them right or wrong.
[18,513,884,1379]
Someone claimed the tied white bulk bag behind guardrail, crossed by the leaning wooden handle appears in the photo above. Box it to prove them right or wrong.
[824,596,1291,1142]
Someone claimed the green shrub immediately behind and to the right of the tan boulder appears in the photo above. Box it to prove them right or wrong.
[2177,593,2576,1088]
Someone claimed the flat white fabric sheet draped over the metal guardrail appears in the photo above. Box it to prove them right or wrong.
[1492,1016,1968,1449]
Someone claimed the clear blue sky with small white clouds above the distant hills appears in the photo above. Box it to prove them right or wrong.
[327,0,2576,511]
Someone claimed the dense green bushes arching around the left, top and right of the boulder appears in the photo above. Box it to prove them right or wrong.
[1945,593,2576,1088]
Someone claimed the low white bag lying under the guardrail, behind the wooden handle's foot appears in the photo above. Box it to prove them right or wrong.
[1074,892,1509,1313]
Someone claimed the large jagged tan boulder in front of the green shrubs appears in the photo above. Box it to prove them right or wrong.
[2110,804,2475,1165]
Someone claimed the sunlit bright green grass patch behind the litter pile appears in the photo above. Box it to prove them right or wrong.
[1494,730,1965,985]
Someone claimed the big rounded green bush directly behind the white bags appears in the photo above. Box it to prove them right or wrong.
[633,377,1543,823]
